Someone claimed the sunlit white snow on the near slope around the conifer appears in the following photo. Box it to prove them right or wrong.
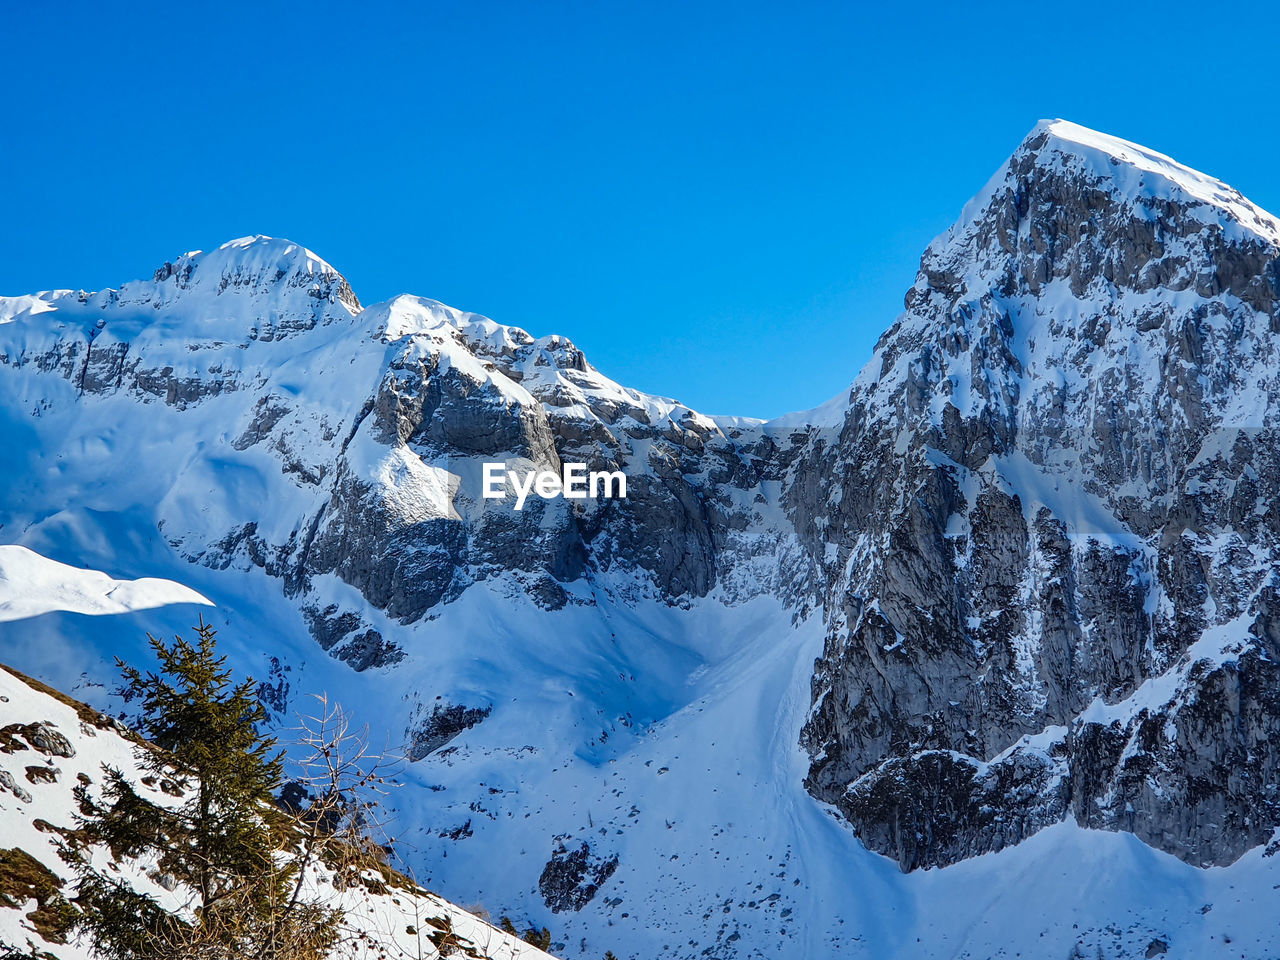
[0,640,547,960]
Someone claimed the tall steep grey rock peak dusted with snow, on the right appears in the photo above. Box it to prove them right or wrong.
[795,118,1280,869]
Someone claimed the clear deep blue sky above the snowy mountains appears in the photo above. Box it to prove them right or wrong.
[0,0,1280,416]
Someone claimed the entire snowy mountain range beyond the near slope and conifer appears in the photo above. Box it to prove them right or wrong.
[0,122,1280,959]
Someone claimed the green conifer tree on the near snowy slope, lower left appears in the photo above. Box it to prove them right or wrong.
[70,618,339,960]
